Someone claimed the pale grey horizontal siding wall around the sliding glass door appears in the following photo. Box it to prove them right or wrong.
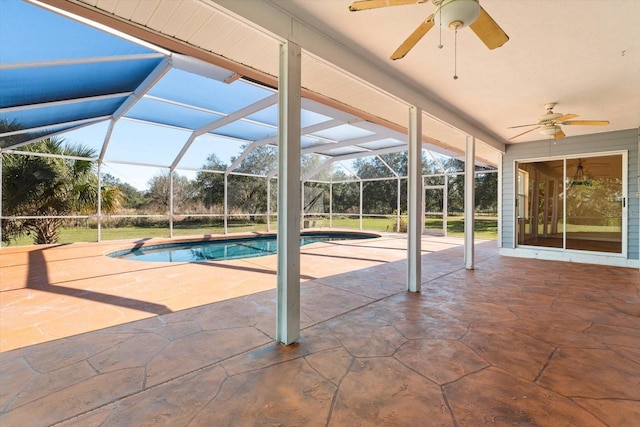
[501,129,640,260]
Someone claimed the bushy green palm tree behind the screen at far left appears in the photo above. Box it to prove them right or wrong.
[2,138,122,244]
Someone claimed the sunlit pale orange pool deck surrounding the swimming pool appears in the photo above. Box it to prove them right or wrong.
[0,233,424,351]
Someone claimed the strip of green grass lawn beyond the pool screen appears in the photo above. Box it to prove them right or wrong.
[3,216,498,246]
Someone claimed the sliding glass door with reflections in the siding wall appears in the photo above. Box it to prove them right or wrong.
[516,154,625,254]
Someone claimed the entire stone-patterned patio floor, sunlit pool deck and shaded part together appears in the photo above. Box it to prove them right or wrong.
[0,234,640,427]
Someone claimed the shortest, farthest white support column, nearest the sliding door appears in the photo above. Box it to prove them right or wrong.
[464,136,476,270]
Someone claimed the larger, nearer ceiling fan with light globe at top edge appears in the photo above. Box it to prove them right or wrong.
[349,0,509,61]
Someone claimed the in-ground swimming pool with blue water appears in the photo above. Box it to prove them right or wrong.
[108,232,380,262]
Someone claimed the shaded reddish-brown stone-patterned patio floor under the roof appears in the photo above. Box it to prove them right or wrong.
[0,242,640,426]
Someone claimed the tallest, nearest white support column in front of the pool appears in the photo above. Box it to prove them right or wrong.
[276,42,302,345]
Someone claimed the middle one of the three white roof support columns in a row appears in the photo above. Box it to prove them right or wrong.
[407,107,422,292]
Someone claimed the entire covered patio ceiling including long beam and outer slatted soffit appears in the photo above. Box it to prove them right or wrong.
[42,0,640,164]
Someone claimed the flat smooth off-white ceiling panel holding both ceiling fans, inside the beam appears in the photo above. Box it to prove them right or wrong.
[269,0,640,143]
